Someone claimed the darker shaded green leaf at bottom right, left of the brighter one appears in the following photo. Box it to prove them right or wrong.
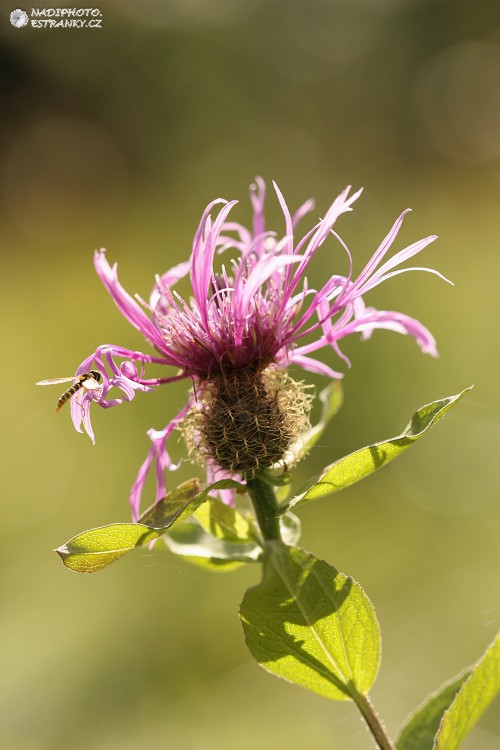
[396,672,470,750]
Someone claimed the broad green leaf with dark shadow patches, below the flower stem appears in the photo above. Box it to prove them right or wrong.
[240,542,380,700]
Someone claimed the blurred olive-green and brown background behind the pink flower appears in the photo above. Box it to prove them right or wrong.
[0,0,500,750]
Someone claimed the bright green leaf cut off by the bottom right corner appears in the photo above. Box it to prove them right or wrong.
[433,633,500,750]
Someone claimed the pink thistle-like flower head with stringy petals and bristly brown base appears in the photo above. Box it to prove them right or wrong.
[60,178,444,519]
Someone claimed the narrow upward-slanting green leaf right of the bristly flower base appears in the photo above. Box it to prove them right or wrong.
[283,388,471,510]
